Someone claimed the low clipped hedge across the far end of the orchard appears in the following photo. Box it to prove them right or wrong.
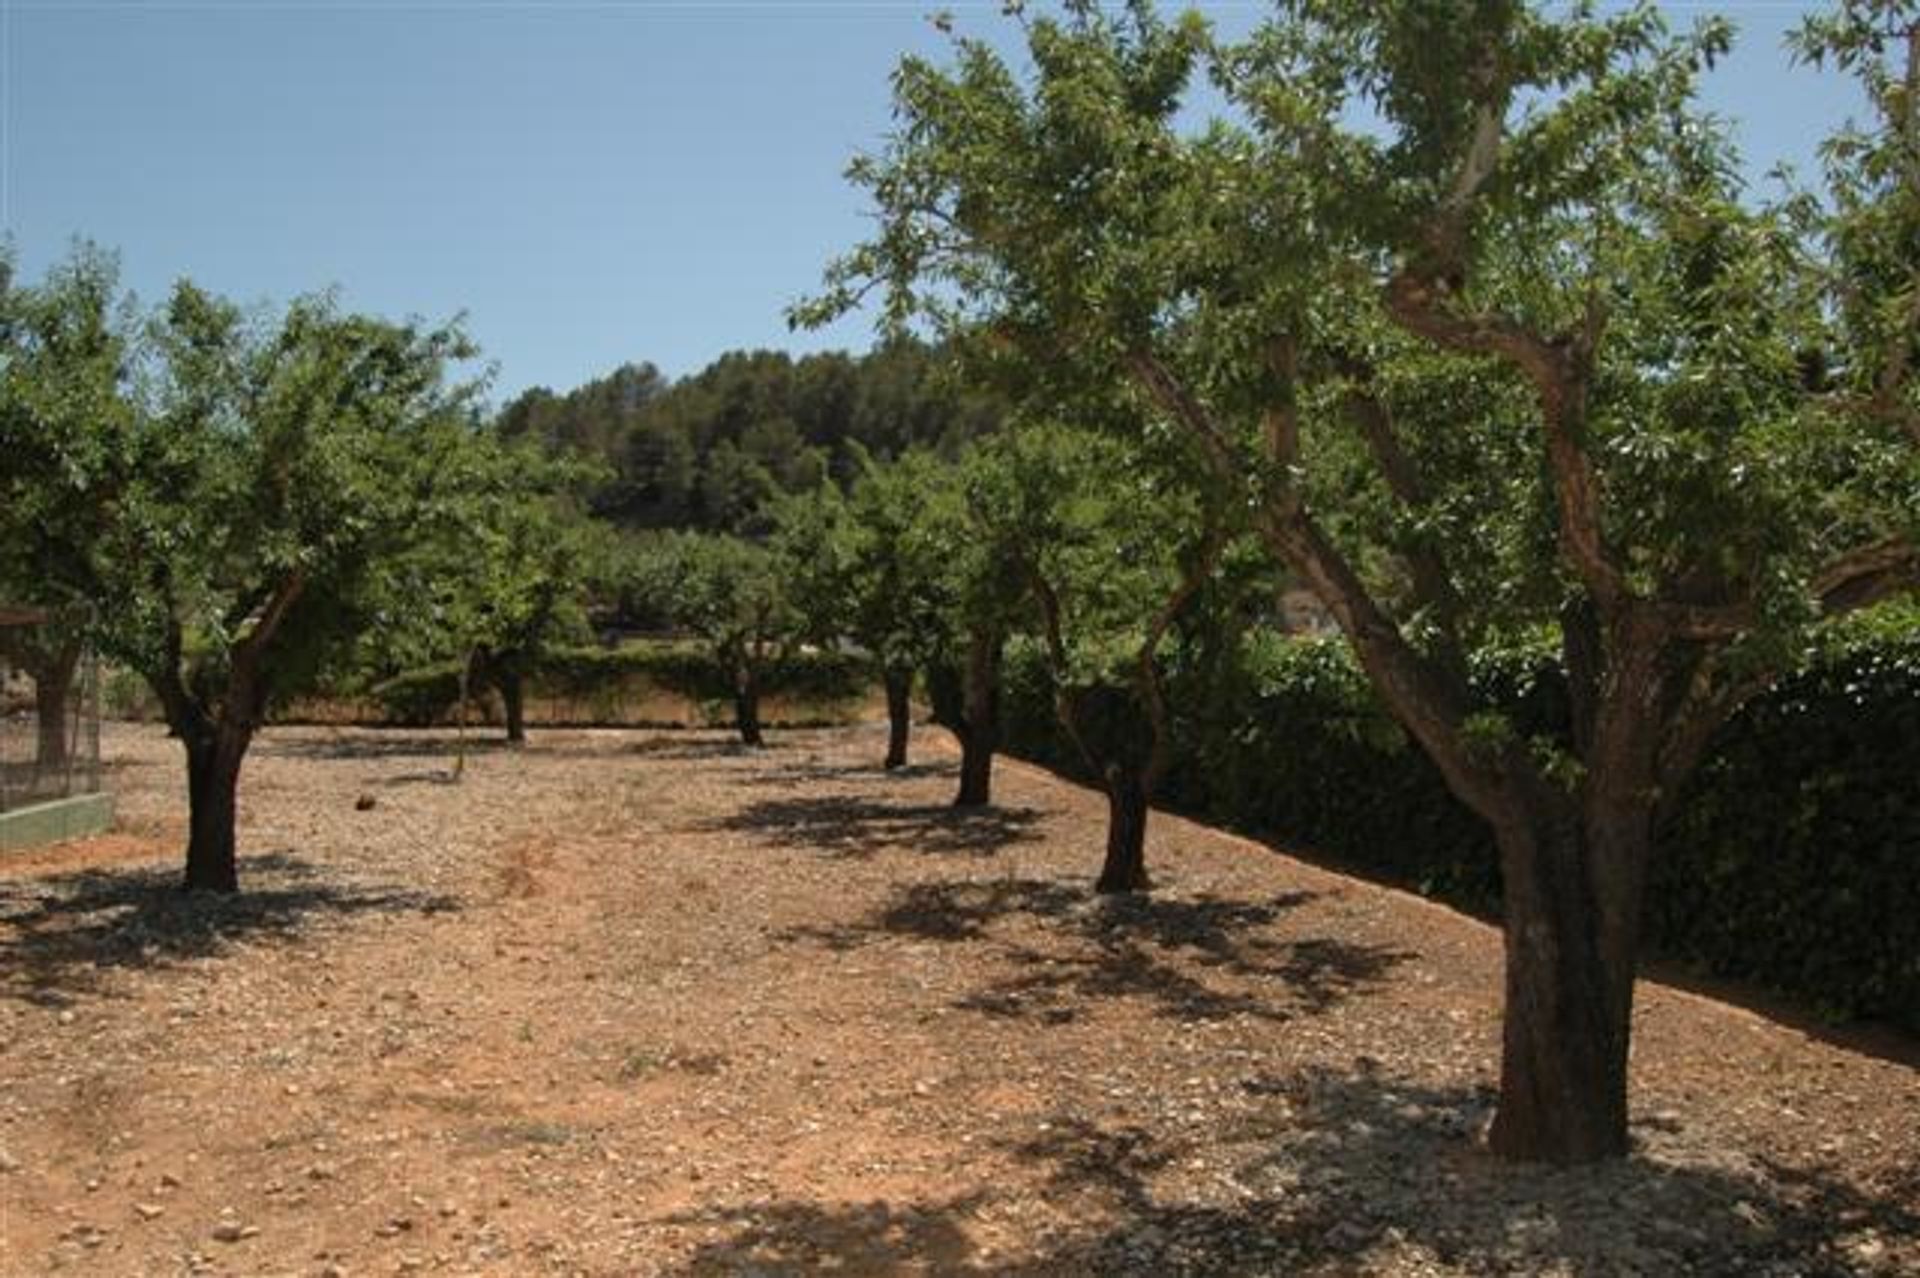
[369,643,877,727]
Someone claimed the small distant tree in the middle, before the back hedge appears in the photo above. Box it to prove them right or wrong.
[630,532,801,746]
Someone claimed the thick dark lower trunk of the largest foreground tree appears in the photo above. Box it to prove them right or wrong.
[1488,800,1651,1165]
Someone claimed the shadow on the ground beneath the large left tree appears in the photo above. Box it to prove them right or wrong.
[0,854,457,1006]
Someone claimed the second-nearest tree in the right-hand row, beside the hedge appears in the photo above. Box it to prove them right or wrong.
[968,424,1227,892]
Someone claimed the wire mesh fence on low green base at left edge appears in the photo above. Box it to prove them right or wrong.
[0,603,100,812]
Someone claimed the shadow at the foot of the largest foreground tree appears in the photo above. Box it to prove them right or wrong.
[670,1071,1920,1278]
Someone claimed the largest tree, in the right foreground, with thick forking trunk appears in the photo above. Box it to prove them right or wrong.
[797,0,1920,1163]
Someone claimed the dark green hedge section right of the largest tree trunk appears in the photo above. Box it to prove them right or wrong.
[1647,610,1920,1029]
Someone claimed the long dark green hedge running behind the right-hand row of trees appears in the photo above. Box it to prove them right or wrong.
[1002,614,1920,1030]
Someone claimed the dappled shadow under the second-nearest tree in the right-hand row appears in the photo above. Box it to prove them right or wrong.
[783,877,1417,1025]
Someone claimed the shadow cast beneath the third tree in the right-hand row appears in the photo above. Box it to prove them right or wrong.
[710,794,1041,858]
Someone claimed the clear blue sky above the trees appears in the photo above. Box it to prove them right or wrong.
[0,0,1853,399]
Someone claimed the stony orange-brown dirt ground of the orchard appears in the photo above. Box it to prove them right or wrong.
[0,727,1920,1274]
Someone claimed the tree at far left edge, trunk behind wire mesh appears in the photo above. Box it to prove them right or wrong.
[0,244,134,768]
